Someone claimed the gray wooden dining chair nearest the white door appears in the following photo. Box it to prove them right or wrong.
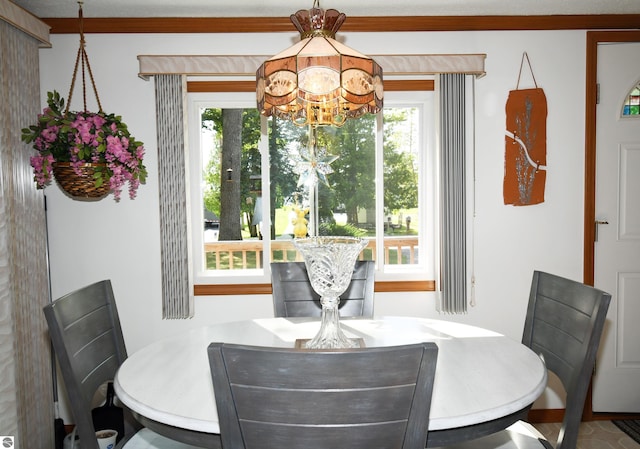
[436,271,611,449]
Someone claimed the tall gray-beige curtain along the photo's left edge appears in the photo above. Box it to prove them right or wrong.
[0,20,54,449]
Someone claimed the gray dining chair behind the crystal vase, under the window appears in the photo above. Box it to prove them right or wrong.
[271,260,375,317]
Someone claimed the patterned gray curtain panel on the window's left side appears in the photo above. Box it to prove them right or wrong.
[154,75,193,319]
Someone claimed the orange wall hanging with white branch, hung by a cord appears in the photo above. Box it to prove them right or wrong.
[503,52,547,206]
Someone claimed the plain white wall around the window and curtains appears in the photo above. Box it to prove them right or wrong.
[40,31,586,418]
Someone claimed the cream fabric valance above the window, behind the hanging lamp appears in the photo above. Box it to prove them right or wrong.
[138,54,487,79]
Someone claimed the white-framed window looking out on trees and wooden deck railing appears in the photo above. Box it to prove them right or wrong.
[188,91,437,284]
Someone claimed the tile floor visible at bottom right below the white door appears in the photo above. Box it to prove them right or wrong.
[534,421,640,449]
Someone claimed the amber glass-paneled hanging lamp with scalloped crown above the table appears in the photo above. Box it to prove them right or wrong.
[256,7,384,126]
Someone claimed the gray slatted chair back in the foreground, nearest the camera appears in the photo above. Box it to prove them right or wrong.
[208,343,438,449]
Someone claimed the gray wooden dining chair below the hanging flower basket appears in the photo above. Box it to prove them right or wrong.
[44,280,195,449]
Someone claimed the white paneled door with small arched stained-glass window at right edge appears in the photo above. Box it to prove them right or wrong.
[593,42,640,413]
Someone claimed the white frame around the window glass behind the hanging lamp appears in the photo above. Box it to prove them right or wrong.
[187,91,439,285]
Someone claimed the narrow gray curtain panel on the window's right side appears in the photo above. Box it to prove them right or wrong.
[438,74,468,313]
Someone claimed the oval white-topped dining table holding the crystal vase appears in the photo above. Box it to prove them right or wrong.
[114,316,547,447]
